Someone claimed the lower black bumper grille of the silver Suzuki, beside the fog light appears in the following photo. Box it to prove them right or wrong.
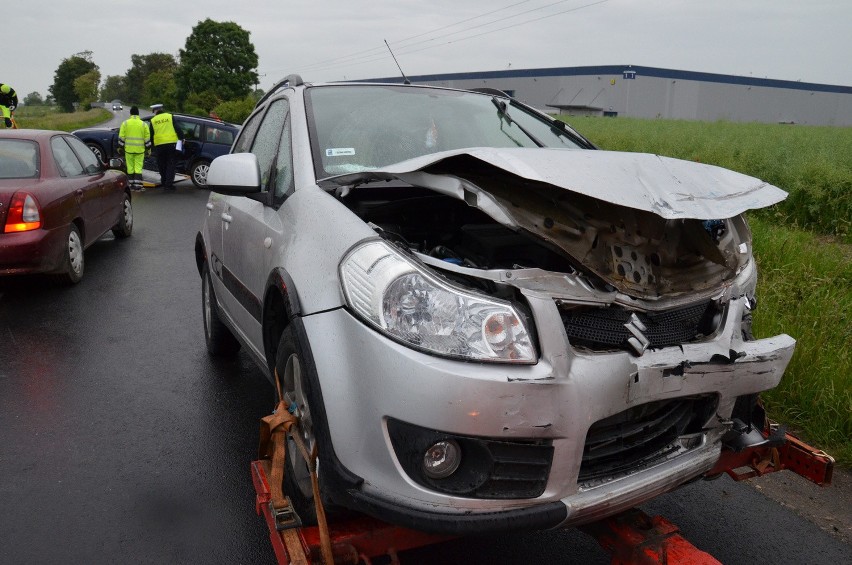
[579,396,716,482]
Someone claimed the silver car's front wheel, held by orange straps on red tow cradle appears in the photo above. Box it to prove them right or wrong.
[275,326,320,526]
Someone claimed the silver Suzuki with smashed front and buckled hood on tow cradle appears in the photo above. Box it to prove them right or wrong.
[195,75,795,534]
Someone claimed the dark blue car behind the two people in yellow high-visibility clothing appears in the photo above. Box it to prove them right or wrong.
[71,114,240,188]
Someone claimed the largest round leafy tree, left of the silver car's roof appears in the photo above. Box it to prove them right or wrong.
[175,18,258,107]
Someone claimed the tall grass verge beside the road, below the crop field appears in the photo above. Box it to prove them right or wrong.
[749,218,852,467]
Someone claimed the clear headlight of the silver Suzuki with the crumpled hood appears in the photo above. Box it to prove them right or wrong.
[340,241,537,363]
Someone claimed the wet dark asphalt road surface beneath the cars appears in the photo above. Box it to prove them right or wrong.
[0,181,852,565]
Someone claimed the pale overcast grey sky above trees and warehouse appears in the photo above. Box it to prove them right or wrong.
[6,0,852,99]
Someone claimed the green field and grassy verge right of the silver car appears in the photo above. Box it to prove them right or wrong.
[563,117,852,467]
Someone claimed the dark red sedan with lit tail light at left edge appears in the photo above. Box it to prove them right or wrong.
[0,129,133,284]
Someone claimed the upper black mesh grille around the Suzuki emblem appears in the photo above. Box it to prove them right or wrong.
[560,301,715,350]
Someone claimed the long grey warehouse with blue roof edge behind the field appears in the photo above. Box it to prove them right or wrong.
[371,65,852,126]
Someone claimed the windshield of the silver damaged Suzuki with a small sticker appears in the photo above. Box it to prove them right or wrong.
[306,85,580,179]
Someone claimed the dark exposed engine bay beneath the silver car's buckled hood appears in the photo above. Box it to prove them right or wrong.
[343,167,750,300]
